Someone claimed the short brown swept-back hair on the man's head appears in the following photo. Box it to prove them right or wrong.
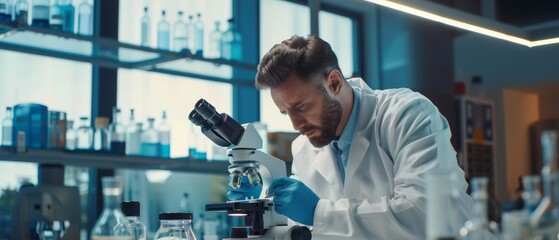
[255,35,341,89]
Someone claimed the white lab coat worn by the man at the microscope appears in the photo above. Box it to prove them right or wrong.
[292,79,472,239]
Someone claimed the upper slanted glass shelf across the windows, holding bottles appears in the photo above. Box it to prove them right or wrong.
[0,22,256,86]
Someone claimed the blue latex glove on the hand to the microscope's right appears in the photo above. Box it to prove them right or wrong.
[268,177,320,226]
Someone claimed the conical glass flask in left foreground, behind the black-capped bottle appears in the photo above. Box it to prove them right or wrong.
[91,177,134,240]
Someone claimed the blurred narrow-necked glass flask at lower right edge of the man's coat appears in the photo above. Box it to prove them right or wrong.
[460,177,497,240]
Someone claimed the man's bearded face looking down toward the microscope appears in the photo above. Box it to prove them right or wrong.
[270,74,342,147]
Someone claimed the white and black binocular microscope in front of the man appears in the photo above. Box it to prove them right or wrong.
[188,99,311,240]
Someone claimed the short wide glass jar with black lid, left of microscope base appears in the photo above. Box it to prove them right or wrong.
[153,212,196,240]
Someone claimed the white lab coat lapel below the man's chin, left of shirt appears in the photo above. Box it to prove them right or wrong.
[313,145,342,192]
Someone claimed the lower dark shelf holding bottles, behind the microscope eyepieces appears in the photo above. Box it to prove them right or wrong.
[0,147,229,174]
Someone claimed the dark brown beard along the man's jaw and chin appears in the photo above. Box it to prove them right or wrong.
[300,89,342,148]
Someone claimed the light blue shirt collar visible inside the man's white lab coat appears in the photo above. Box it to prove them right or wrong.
[330,89,359,182]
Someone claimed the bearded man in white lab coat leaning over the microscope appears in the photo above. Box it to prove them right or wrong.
[228,36,472,239]
